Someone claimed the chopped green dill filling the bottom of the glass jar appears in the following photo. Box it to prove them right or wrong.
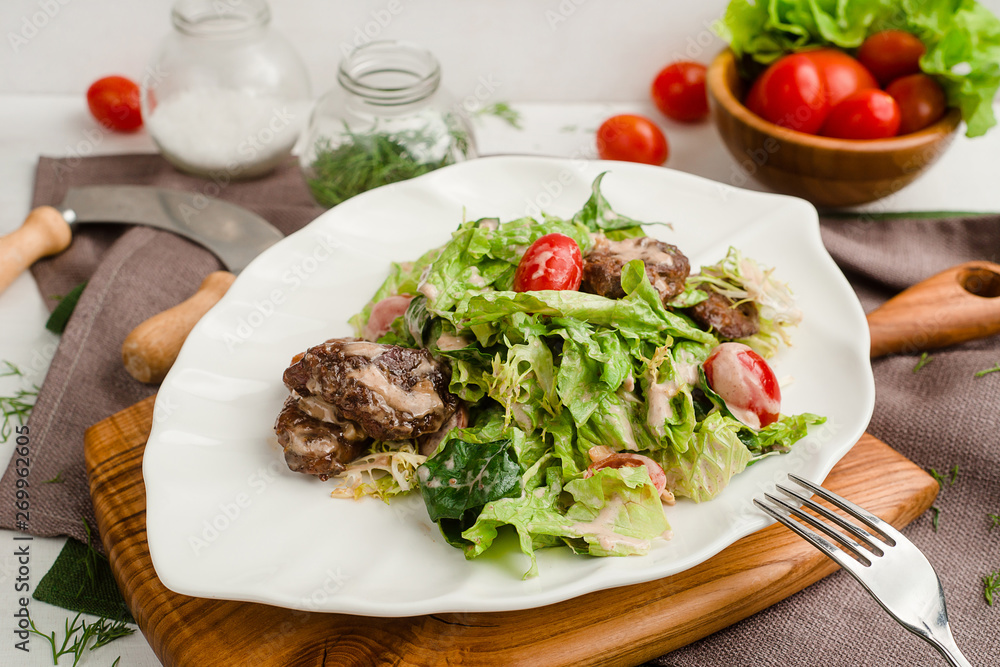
[308,122,469,208]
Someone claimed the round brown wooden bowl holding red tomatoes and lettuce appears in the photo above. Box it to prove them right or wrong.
[707,49,961,207]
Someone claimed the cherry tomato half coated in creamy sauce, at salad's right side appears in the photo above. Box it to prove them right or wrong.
[702,343,781,429]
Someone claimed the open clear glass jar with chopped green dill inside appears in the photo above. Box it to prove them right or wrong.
[300,41,475,208]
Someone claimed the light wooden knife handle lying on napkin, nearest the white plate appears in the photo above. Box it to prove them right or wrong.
[122,271,236,384]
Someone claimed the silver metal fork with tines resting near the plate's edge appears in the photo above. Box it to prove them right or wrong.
[754,474,971,667]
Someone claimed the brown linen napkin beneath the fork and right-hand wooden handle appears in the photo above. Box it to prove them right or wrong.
[649,216,1000,667]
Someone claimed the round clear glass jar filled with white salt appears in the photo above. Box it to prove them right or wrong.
[142,0,310,181]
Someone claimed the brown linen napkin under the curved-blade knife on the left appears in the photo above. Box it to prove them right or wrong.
[0,155,322,547]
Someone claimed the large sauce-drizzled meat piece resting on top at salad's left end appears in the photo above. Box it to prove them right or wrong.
[284,338,458,440]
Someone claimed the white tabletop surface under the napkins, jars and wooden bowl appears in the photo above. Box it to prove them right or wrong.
[0,94,1000,667]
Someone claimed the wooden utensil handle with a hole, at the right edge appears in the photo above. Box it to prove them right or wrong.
[868,262,1000,358]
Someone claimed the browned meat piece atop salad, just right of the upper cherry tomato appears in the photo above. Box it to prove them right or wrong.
[583,236,691,304]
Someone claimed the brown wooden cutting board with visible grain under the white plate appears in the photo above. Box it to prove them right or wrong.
[86,398,938,667]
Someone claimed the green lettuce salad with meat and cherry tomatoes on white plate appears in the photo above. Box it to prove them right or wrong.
[275,175,823,576]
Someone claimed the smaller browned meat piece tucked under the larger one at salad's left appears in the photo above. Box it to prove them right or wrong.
[274,396,371,481]
